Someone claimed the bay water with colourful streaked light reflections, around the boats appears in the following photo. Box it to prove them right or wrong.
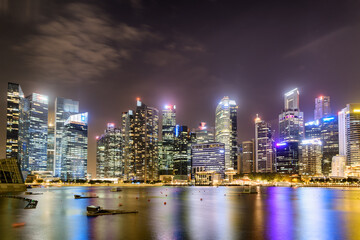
[0,187,360,239]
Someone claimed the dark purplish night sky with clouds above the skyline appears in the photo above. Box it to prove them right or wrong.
[0,0,360,176]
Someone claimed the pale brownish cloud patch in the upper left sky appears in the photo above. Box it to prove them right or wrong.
[16,3,156,83]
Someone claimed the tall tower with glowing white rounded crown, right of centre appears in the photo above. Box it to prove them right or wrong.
[215,97,238,170]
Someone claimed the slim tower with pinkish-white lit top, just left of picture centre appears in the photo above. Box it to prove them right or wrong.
[159,105,176,175]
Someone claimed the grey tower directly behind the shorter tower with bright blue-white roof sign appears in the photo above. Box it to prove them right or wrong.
[53,98,79,177]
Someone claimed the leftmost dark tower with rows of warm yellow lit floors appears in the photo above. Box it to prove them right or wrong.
[6,82,24,163]
